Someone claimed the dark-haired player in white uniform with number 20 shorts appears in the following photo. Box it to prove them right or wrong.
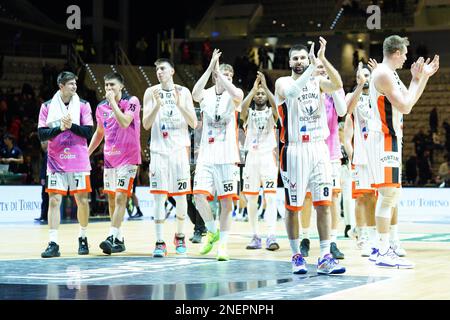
[143,58,197,258]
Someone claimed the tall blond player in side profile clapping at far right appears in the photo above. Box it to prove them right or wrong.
[368,35,439,268]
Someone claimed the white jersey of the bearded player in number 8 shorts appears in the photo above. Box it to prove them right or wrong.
[278,77,330,144]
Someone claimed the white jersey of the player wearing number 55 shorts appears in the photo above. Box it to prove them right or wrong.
[197,86,239,164]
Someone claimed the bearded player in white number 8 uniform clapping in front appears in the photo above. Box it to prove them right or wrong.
[275,37,345,274]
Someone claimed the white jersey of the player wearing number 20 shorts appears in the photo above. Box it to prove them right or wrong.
[150,87,191,154]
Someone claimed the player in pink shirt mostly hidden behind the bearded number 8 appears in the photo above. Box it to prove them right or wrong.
[300,60,347,259]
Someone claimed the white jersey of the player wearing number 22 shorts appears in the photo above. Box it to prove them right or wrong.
[244,106,277,152]
